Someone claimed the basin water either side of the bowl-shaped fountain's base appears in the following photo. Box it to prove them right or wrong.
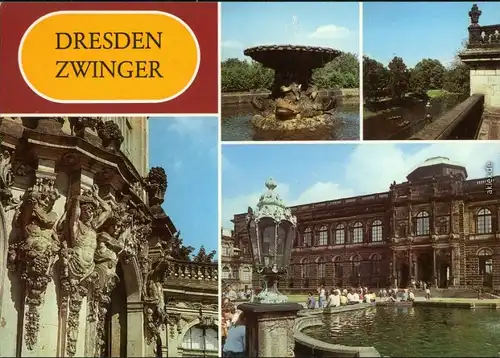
[221,103,360,141]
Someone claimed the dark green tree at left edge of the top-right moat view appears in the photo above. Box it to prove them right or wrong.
[363,56,389,98]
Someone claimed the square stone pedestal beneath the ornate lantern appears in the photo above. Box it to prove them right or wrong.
[238,303,302,357]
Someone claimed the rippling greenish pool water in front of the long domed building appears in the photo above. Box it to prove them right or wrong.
[303,307,500,357]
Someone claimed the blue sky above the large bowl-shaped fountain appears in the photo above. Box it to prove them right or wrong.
[221,2,359,60]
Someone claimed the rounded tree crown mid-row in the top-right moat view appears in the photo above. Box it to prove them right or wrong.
[410,58,446,94]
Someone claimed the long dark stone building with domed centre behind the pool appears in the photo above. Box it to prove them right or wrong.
[234,157,500,291]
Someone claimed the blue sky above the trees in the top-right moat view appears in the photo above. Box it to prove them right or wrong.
[363,1,500,67]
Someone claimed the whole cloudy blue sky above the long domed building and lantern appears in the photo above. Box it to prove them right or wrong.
[222,141,500,229]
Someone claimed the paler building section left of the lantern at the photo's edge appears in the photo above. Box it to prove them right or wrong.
[221,229,253,292]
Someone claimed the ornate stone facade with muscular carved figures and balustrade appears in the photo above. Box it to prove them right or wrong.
[0,117,218,357]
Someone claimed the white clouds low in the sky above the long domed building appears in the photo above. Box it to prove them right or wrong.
[222,142,500,228]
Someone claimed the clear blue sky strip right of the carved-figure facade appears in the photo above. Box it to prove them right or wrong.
[149,117,220,252]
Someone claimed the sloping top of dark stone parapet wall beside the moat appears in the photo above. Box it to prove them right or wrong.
[410,94,485,140]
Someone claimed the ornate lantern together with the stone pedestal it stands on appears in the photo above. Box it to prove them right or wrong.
[238,179,302,357]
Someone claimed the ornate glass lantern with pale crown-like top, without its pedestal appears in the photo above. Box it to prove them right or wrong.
[247,179,297,303]
